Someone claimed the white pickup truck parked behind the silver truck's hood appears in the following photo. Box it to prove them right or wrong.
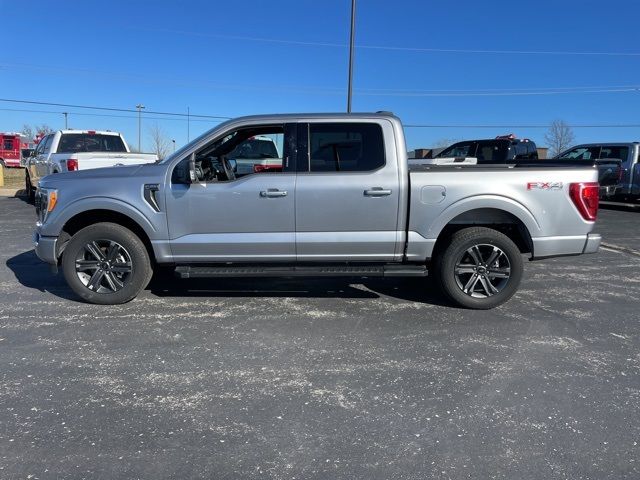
[25,130,158,199]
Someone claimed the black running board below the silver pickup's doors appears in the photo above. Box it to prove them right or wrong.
[175,265,427,278]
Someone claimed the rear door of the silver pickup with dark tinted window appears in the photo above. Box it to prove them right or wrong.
[295,120,400,262]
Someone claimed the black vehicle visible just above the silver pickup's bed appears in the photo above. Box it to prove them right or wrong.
[434,135,538,164]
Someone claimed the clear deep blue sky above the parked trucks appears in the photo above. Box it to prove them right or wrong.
[0,0,640,148]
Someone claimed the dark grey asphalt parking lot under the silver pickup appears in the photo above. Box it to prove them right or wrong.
[0,198,640,479]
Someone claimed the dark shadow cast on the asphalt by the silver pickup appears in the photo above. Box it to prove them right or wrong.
[6,250,450,306]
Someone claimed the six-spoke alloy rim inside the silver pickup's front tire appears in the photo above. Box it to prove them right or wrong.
[76,240,133,293]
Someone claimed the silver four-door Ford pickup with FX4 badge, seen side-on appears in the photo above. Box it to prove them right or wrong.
[34,112,600,309]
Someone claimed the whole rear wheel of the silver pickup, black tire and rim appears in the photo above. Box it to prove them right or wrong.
[434,227,524,310]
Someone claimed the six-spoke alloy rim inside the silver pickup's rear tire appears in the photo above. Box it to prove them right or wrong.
[455,244,511,298]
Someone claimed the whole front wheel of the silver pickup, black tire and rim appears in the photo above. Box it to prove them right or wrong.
[62,223,153,305]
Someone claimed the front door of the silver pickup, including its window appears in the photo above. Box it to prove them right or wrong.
[165,125,296,263]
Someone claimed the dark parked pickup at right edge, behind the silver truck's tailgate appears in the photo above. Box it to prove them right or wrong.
[556,142,640,201]
